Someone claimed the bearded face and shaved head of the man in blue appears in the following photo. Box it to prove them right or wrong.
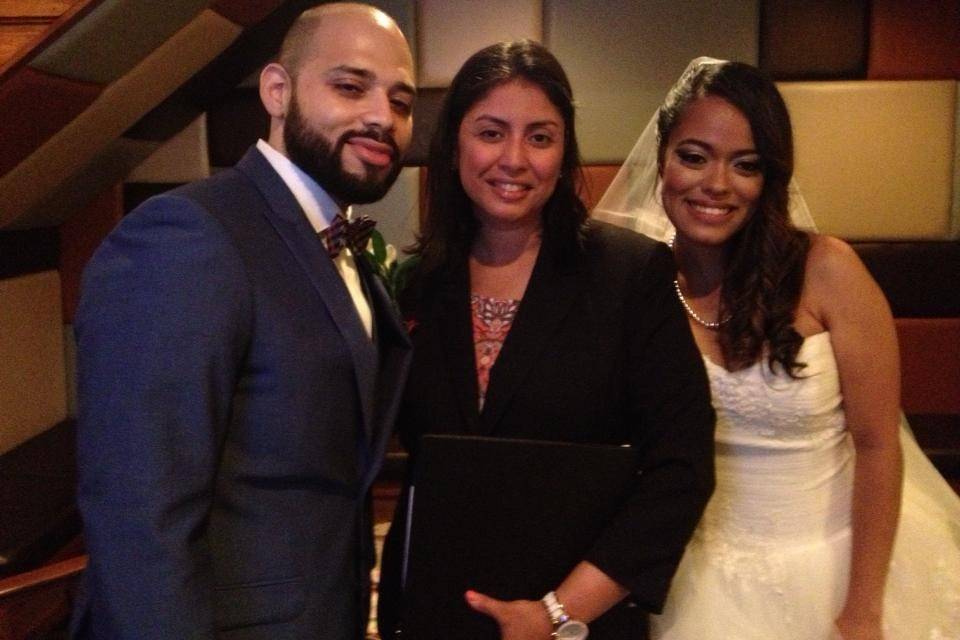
[265,10,415,204]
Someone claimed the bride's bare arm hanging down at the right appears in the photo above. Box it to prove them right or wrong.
[807,236,903,640]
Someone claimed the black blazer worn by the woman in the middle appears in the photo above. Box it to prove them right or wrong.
[380,221,714,637]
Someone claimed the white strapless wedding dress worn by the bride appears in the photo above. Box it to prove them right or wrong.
[651,332,960,640]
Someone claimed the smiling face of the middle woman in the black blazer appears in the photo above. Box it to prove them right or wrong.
[457,80,565,228]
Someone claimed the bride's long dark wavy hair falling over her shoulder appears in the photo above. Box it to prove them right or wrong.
[657,62,810,377]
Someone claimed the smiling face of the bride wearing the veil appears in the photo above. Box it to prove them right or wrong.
[660,95,763,245]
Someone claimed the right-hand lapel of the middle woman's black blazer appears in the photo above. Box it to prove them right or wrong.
[480,244,585,434]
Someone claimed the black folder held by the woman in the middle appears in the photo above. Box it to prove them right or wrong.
[403,435,637,640]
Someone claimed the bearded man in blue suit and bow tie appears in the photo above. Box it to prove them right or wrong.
[73,3,415,640]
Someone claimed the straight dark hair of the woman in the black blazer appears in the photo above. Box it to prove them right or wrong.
[413,40,587,276]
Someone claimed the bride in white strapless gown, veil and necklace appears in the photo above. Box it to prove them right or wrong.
[594,58,960,640]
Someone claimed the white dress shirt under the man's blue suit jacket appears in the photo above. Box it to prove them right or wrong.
[257,139,373,337]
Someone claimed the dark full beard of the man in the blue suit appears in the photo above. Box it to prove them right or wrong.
[283,95,400,204]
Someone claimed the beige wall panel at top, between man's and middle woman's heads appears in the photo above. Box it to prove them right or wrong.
[417,0,543,87]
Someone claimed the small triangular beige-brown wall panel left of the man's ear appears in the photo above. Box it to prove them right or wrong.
[127,114,210,183]
